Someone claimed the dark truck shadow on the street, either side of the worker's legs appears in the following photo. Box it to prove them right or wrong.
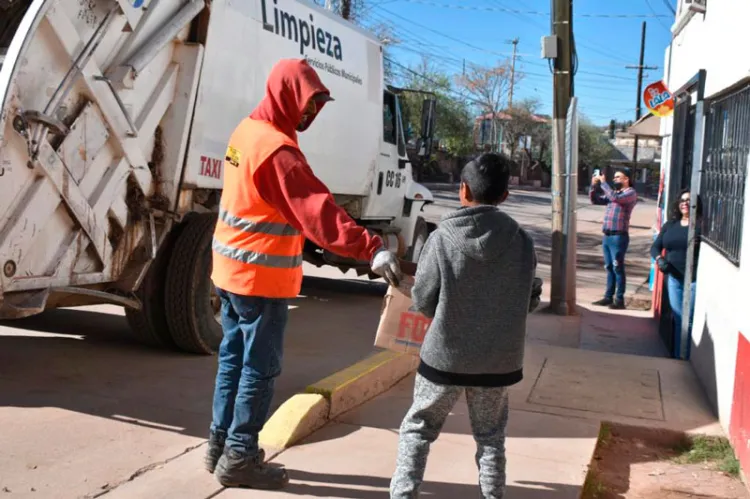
[0,279,384,438]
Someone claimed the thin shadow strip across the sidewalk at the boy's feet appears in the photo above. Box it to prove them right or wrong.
[284,470,580,499]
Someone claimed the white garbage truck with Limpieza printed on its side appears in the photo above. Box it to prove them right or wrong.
[0,0,435,354]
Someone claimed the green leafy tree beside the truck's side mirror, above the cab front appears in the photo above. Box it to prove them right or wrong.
[400,58,474,155]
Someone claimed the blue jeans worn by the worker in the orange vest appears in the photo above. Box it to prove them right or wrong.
[211,288,288,456]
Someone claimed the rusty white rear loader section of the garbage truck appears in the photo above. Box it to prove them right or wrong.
[0,0,204,317]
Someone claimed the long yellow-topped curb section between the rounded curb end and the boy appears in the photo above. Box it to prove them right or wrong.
[305,351,419,419]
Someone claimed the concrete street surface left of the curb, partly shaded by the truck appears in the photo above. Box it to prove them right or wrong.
[0,268,384,499]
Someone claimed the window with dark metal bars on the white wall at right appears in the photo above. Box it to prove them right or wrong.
[701,84,750,265]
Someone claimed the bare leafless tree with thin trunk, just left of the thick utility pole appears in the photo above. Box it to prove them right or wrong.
[457,60,521,151]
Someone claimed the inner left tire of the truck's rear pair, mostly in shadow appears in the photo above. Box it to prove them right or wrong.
[125,214,198,348]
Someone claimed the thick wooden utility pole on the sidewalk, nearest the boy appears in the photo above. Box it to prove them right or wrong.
[550,0,578,315]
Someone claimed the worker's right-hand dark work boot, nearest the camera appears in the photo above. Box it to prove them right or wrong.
[215,449,289,490]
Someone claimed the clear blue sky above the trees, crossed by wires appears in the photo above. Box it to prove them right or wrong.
[367,0,676,124]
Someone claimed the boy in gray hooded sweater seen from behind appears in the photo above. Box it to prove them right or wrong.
[391,153,537,499]
